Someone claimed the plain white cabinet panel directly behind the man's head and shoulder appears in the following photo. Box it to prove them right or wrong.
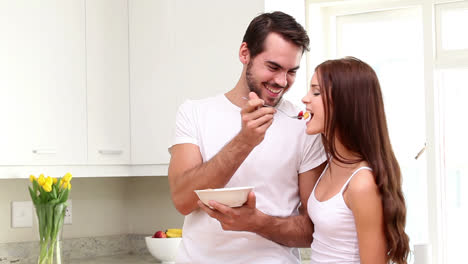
[129,0,264,165]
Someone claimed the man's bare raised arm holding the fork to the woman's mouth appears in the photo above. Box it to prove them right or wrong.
[168,93,275,215]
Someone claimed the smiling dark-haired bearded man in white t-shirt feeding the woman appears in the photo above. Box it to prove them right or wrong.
[169,12,325,264]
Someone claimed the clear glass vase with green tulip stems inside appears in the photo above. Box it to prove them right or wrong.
[35,203,66,264]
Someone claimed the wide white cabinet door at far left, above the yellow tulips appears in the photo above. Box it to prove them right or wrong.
[0,0,86,165]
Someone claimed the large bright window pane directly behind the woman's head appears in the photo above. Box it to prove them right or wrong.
[320,3,427,253]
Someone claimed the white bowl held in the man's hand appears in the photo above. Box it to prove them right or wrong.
[195,186,253,208]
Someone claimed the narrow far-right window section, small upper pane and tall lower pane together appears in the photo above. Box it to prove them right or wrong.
[434,1,468,263]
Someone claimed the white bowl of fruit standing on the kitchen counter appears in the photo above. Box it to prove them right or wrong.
[145,236,182,264]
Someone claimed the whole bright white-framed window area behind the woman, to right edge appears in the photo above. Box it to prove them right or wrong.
[306,0,468,264]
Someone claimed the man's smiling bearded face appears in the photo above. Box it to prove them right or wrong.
[246,33,302,106]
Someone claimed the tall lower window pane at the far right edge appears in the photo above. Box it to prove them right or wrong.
[440,68,468,263]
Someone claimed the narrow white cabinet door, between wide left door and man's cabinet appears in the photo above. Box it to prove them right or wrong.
[86,0,130,164]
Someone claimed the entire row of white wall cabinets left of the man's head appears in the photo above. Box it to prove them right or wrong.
[0,0,264,178]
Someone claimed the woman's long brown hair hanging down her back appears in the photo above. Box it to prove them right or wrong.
[315,57,409,264]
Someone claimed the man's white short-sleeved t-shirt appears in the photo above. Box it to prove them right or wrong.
[172,94,325,264]
